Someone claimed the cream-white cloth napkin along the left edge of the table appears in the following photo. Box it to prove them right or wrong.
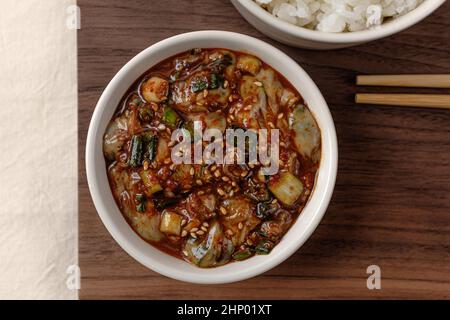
[0,0,78,299]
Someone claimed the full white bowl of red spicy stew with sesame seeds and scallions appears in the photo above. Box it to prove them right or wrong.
[86,31,337,284]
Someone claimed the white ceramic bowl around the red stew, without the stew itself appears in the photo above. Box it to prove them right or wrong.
[86,31,338,284]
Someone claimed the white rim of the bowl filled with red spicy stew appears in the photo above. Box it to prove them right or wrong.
[85,30,338,284]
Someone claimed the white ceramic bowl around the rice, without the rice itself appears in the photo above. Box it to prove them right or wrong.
[231,0,445,49]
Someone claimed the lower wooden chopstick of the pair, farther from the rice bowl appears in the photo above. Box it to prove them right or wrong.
[355,93,450,109]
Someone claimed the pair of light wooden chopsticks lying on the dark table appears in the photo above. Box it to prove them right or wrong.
[355,74,450,109]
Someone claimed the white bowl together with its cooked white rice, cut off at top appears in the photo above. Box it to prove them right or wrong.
[231,0,445,49]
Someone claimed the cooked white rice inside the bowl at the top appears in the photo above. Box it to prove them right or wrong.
[254,0,424,32]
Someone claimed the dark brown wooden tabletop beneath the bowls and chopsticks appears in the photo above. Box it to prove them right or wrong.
[78,0,450,299]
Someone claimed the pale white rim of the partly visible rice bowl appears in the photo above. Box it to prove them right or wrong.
[232,0,446,44]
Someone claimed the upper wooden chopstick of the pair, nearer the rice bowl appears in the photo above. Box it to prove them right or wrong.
[356,74,450,88]
